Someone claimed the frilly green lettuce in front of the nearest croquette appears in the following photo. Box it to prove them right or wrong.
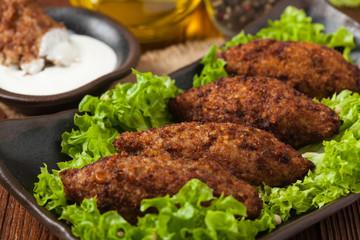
[60,179,276,240]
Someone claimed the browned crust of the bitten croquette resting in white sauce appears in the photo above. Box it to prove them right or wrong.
[0,0,63,66]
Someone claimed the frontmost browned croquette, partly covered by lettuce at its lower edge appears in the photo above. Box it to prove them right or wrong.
[60,155,263,223]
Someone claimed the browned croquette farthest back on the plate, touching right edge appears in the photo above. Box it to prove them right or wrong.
[219,39,360,99]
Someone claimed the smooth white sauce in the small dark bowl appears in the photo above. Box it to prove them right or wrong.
[0,34,117,95]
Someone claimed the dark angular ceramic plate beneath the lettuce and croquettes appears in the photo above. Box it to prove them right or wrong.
[0,0,360,240]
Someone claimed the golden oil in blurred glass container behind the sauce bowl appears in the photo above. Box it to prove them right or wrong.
[70,0,201,43]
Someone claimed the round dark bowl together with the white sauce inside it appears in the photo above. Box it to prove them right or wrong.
[0,7,140,115]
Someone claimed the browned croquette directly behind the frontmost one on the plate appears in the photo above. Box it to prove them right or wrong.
[114,122,314,187]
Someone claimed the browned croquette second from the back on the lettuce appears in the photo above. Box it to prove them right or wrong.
[169,76,341,148]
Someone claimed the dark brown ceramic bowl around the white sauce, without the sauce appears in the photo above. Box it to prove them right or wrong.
[0,7,140,114]
